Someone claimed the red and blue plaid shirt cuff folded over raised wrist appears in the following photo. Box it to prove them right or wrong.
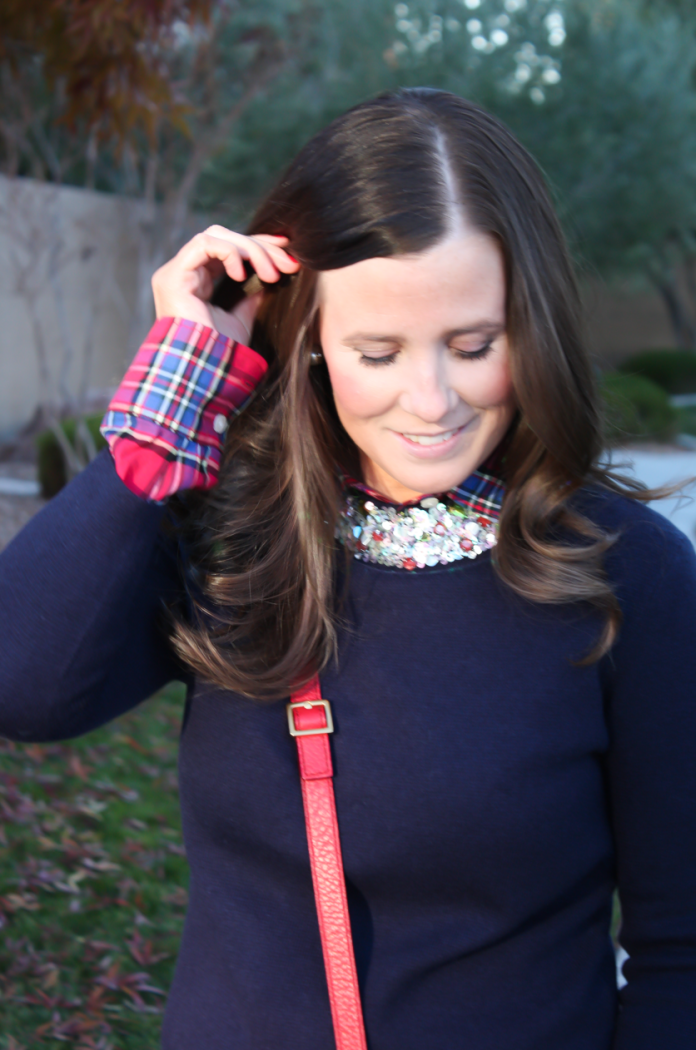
[101,317,268,501]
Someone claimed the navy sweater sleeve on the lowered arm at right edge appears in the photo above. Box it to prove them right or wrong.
[608,511,696,1050]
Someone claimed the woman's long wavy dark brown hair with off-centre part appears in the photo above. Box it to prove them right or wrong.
[173,88,649,698]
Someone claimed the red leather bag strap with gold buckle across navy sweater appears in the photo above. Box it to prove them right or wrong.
[288,677,367,1050]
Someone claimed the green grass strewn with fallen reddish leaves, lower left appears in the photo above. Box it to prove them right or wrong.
[0,683,188,1050]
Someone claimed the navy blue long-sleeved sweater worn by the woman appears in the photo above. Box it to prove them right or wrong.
[0,454,696,1050]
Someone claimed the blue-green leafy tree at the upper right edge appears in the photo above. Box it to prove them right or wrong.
[514,5,696,348]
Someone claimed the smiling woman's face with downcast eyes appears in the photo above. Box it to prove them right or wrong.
[319,228,514,502]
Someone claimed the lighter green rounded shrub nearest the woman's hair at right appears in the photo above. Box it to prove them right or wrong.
[602,372,679,444]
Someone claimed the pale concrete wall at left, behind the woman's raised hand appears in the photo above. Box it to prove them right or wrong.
[0,177,136,437]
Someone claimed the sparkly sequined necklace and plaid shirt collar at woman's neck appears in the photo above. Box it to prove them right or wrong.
[336,454,505,571]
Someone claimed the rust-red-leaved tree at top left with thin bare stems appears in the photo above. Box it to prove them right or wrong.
[0,0,211,455]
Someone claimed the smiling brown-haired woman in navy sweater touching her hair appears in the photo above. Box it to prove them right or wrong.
[0,89,696,1050]
